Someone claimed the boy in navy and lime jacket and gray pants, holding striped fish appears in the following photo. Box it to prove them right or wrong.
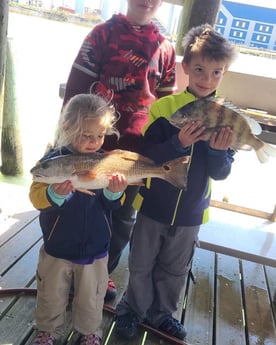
[115,25,235,339]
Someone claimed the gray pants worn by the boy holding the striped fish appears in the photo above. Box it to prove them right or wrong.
[117,213,200,327]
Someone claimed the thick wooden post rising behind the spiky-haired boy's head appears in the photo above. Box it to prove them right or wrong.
[176,0,221,55]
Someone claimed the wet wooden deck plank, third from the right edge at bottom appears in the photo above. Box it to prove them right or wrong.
[216,254,246,345]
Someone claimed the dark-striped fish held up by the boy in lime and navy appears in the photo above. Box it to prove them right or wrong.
[169,97,276,163]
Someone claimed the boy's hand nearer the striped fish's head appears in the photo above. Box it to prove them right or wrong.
[178,121,206,148]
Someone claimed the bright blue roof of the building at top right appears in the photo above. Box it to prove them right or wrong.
[223,1,276,24]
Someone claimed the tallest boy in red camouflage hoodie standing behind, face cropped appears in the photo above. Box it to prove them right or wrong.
[64,0,175,300]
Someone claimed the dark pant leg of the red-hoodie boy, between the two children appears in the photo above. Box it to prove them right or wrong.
[108,186,139,273]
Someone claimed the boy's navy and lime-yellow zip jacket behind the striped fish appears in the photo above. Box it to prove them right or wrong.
[134,92,234,226]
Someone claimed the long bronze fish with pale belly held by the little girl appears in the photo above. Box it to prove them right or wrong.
[30,150,188,194]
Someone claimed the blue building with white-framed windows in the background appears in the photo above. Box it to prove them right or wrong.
[216,0,276,50]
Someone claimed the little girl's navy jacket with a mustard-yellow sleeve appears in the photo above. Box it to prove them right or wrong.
[30,149,121,260]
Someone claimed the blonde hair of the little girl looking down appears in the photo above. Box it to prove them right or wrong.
[55,94,119,147]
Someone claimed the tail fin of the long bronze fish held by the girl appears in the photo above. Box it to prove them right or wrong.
[163,156,190,190]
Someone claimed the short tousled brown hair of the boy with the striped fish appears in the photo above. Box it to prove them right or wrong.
[182,24,237,67]
